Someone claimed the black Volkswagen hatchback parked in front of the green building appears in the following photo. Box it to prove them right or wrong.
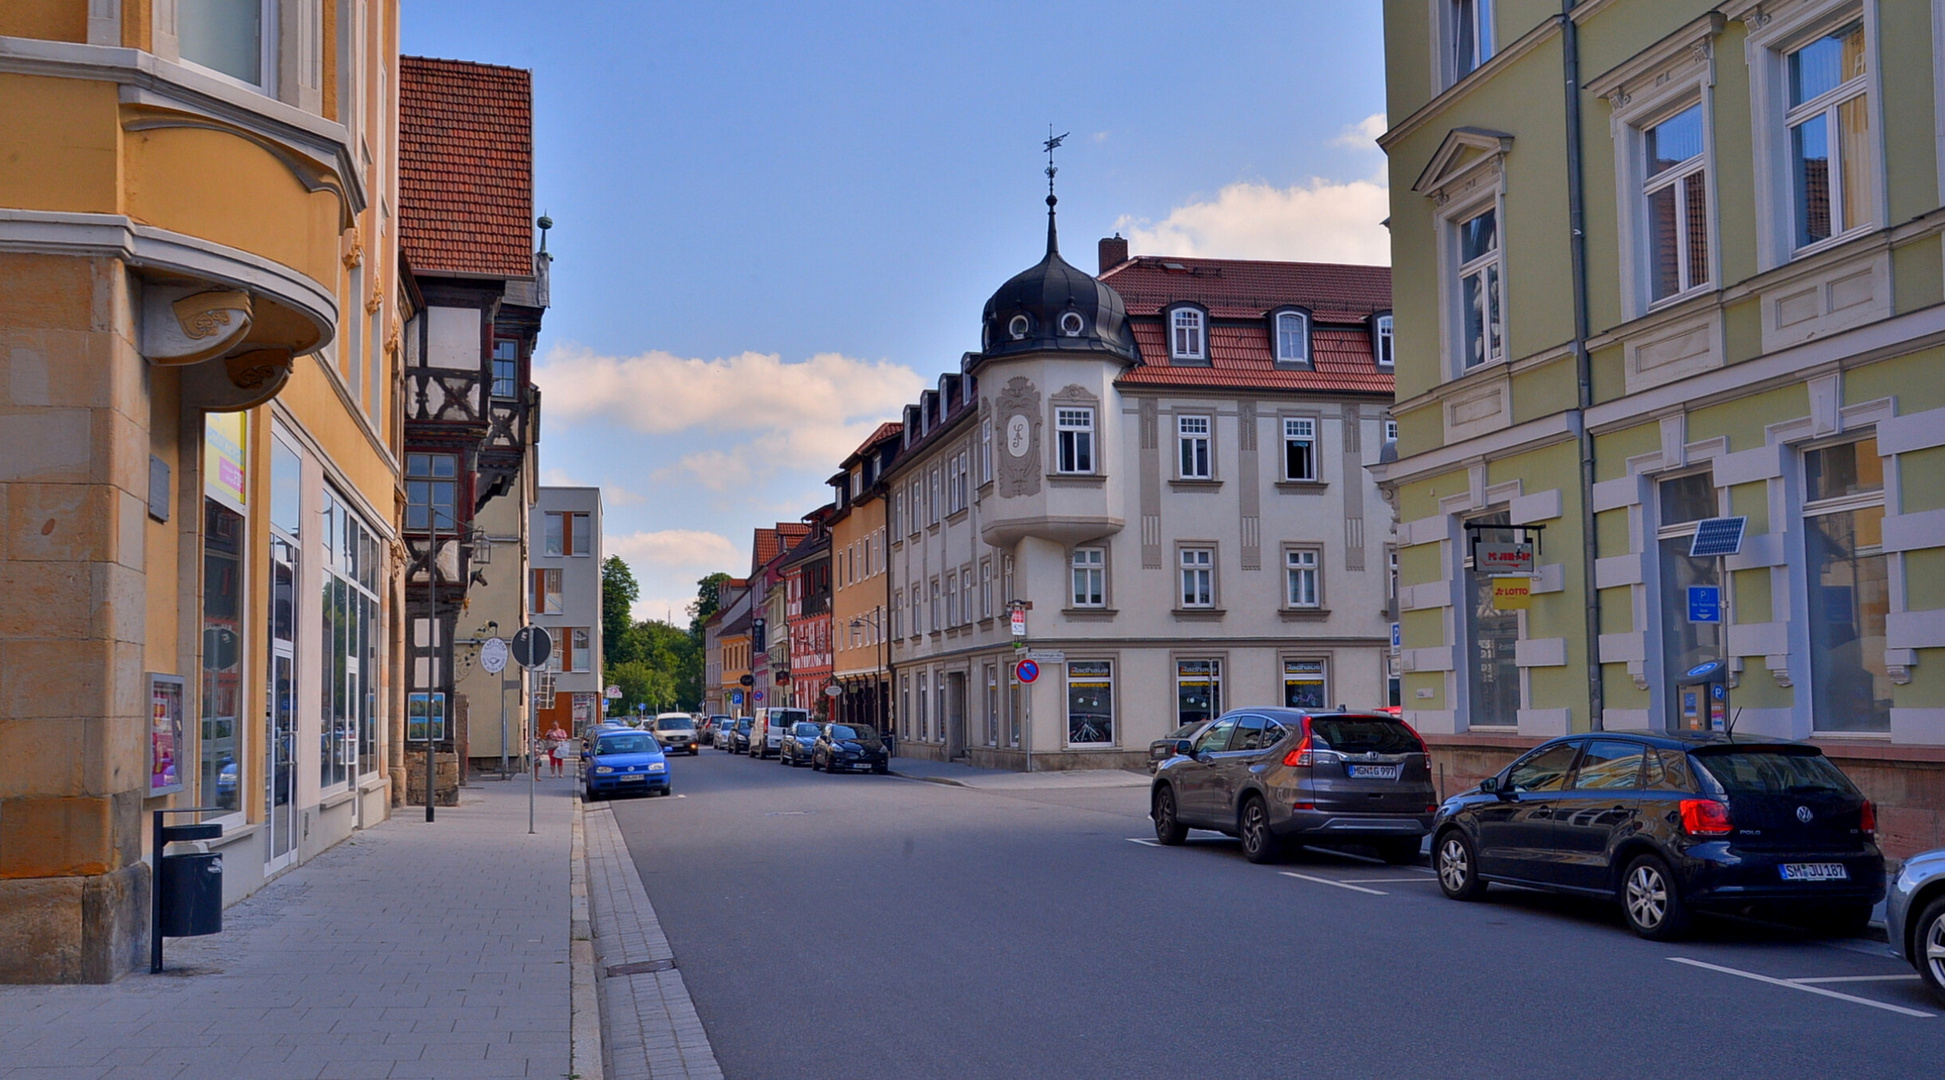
[1432,732,1885,940]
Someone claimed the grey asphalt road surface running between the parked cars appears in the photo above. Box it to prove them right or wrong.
[615,749,1945,1080]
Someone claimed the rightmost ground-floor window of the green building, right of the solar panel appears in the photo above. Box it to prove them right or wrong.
[1803,438,1891,732]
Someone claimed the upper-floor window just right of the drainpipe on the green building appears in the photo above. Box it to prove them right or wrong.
[1642,103,1710,300]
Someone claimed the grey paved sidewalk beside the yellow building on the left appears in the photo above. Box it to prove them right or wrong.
[0,780,574,1080]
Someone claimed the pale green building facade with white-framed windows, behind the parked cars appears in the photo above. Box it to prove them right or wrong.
[1377,0,1945,854]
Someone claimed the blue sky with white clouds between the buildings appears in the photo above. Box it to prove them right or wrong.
[403,0,1389,621]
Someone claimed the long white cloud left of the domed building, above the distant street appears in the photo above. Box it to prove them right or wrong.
[535,346,924,469]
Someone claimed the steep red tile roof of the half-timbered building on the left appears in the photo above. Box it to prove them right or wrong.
[399,56,533,278]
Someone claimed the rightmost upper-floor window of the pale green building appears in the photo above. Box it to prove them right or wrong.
[1784,21,1875,247]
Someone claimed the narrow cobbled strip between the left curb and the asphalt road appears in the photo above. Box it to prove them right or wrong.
[582,804,724,1080]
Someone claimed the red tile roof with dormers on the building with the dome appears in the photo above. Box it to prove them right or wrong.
[1101,255,1397,395]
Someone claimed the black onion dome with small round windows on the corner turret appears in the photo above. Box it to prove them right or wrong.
[980,195,1140,364]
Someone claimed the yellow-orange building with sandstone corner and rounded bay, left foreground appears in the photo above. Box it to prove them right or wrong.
[0,0,401,983]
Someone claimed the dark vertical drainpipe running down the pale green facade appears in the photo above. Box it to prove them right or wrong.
[1560,0,1607,732]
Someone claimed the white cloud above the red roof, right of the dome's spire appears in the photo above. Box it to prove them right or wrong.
[1114,179,1391,265]
